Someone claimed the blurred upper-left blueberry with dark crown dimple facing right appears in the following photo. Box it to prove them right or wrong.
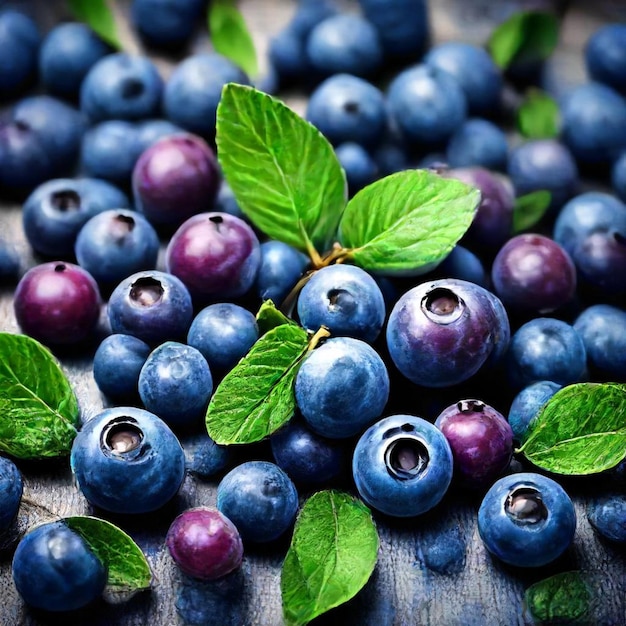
[80,52,163,123]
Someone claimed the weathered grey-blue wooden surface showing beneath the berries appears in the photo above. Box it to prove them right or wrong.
[0,0,626,626]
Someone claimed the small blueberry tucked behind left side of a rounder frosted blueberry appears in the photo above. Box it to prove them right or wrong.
[92,333,151,403]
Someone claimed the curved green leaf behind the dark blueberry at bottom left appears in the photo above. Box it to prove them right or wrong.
[63,515,152,594]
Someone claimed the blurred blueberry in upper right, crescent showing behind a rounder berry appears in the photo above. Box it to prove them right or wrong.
[422,41,504,116]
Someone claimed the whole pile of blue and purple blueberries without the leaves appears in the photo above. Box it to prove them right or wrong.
[0,0,626,610]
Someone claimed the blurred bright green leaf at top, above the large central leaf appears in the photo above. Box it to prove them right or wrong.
[208,0,259,78]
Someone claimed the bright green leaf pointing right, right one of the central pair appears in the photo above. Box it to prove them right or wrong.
[339,169,480,274]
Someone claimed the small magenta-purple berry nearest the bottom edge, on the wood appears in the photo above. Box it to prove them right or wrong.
[165,507,243,580]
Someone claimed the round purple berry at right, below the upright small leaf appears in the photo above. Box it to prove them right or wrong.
[491,233,577,315]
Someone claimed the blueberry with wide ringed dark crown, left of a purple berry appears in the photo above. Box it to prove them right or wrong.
[352,414,453,517]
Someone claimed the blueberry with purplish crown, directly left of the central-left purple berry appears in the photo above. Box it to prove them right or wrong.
[74,209,160,286]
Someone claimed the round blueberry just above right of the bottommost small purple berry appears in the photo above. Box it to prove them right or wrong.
[217,461,298,543]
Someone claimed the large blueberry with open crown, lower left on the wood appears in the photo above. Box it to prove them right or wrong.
[70,406,185,514]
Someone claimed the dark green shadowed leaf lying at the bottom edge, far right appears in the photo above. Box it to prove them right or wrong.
[524,572,592,624]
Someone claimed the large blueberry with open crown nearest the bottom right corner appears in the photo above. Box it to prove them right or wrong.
[478,472,576,567]
